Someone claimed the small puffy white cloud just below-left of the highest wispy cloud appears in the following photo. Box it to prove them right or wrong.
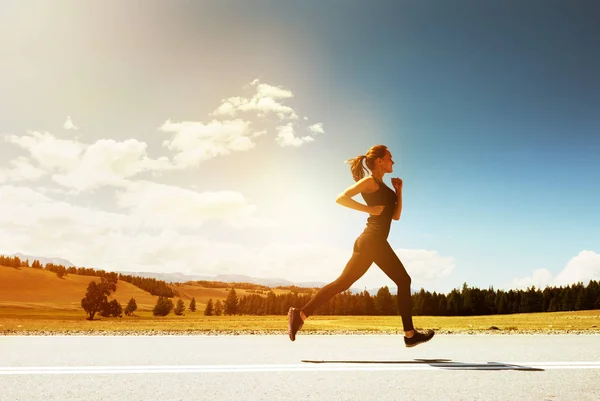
[160,119,255,167]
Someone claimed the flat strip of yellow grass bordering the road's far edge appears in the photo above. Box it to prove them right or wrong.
[0,307,600,335]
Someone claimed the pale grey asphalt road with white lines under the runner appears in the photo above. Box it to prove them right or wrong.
[0,334,600,401]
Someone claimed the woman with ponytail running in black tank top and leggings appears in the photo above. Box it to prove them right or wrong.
[288,145,434,347]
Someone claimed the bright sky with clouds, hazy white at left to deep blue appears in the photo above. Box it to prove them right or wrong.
[0,0,600,292]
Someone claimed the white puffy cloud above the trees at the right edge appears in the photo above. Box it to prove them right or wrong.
[512,250,600,288]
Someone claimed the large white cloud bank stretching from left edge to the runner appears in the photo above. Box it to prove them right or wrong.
[0,184,338,280]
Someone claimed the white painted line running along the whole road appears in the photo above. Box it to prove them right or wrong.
[0,361,600,376]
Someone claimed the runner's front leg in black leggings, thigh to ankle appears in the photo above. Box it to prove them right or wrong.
[374,241,414,332]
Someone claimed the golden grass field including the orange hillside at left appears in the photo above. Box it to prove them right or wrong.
[0,266,600,334]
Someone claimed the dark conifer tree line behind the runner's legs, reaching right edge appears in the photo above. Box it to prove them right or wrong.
[212,280,600,316]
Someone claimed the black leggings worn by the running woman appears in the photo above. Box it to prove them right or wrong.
[302,233,414,331]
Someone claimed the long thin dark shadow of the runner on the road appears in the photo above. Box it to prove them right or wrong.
[302,359,544,372]
